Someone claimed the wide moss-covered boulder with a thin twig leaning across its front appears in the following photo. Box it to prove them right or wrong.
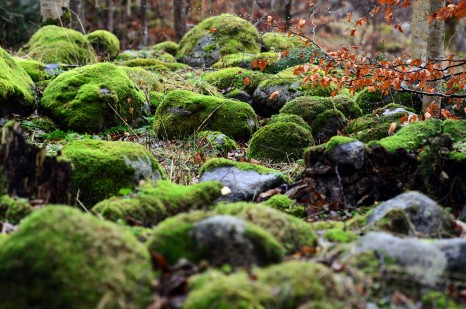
[154,90,257,140]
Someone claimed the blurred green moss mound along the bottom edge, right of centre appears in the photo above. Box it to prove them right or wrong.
[184,261,345,309]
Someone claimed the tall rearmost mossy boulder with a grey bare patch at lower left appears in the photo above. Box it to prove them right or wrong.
[177,14,260,67]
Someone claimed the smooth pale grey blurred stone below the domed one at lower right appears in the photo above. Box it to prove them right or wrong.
[355,232,447,285]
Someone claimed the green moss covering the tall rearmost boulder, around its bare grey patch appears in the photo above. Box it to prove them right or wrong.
[177,14,260,59]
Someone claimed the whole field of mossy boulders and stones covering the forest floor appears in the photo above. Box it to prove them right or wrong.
[0,15,466,309]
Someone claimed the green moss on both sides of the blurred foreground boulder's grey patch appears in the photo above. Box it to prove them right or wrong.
[147,211,283,266]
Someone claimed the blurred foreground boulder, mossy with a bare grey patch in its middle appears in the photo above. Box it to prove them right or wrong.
[147,212,283,267]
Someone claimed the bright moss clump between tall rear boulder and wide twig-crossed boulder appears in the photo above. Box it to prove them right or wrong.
[202,68,266,94]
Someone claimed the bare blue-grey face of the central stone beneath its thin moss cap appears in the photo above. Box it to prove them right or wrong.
[199,166,284,202]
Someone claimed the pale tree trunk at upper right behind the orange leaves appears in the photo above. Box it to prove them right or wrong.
[411,0,445,110]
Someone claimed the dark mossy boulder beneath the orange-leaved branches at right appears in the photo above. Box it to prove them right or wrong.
[355,88,422,114]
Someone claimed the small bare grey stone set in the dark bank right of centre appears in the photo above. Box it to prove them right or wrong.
[328,141,366,170]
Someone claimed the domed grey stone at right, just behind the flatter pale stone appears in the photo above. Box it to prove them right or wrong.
[367,191,451,237]
